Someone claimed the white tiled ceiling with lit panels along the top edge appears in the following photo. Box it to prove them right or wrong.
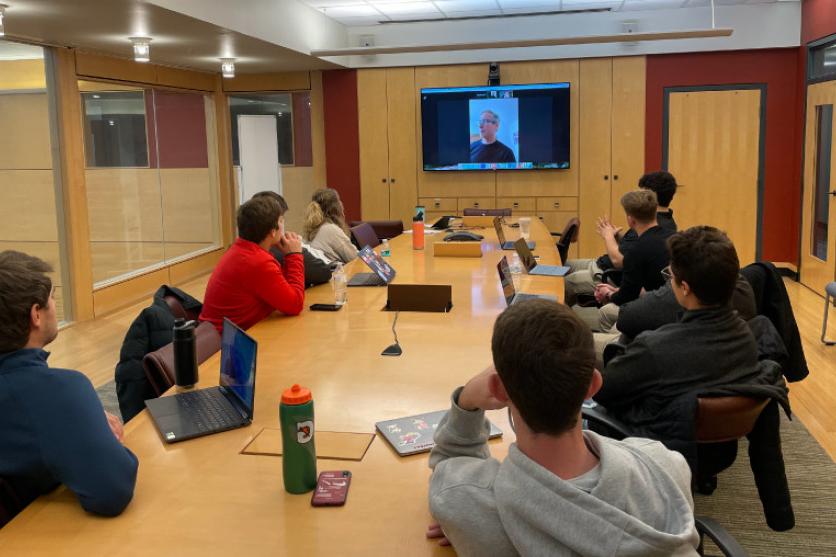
[301,0,796,27]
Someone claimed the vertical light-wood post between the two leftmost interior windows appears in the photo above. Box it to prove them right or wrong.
[52,48,95,321]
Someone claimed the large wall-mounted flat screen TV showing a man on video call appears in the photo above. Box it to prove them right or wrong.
[421,83,569,170]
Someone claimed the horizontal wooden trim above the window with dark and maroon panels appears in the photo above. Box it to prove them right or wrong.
[75,51,218,92]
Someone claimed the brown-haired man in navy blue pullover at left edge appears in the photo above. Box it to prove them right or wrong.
[0,251,138,516]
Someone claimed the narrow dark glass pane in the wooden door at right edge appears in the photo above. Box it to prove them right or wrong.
[811,104,833,261]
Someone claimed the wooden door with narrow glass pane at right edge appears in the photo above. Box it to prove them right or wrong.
[800,81,836,294]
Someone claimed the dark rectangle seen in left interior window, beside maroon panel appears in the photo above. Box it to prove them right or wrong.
[81,91,148,168]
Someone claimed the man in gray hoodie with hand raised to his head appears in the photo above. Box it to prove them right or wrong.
[427,300,699,557]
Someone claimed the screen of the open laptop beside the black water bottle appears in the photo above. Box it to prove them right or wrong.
[220,318,258,419]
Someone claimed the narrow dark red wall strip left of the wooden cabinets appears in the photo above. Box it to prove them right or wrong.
[322,70,360,220]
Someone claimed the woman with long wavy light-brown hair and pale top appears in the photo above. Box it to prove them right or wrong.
[302,188,357,263]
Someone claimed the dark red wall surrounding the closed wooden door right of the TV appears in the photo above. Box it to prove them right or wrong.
[645,47,804,263]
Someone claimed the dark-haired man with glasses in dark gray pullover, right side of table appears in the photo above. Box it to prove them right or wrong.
[594,226,761,439]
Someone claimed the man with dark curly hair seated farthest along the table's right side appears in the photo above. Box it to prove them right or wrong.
[565,170,676,306]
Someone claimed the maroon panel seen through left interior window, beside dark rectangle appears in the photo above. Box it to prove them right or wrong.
[154,89,209,168]
